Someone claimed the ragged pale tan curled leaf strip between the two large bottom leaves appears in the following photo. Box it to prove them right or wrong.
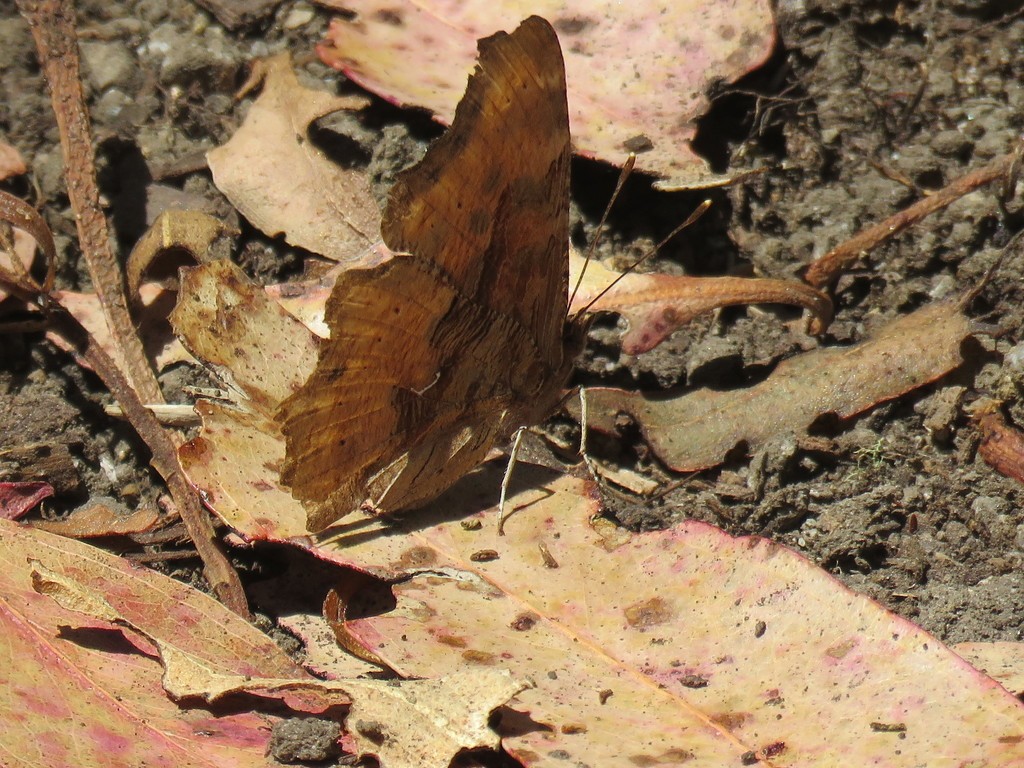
[31,536,528,768]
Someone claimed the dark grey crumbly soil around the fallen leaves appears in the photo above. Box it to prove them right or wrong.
[0,0,1024,667]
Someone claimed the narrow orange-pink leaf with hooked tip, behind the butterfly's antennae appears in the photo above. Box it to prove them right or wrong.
[569,254,831,354]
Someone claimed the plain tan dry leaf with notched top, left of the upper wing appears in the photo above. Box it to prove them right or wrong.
[207,54,380,261]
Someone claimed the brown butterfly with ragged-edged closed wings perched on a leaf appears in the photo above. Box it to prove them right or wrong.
[280,16,586,531]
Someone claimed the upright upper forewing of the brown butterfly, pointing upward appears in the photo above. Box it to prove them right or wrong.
[381,16,571,369]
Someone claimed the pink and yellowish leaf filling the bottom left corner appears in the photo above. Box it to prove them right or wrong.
[0,521,302,768]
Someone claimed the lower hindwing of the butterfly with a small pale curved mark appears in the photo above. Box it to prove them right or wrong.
[279,256,537,530]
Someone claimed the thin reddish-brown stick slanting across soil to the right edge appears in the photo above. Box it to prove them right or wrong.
[804,145,1018,288]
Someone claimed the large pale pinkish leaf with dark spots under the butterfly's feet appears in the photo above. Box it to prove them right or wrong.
[309,469,1024,768]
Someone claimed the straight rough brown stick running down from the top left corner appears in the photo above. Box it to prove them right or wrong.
[17,0,164,402]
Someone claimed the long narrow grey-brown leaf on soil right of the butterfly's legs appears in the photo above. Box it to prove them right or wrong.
[569,302,972,472]
